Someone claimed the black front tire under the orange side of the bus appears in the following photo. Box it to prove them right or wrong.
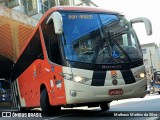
[40,88,61,115]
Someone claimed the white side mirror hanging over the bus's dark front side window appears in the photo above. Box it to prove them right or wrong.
[46,12,63,34]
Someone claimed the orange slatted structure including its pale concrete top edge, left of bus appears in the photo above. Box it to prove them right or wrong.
[0,6,38,61]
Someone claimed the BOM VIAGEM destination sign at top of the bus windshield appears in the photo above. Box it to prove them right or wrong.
[68,15,93,20]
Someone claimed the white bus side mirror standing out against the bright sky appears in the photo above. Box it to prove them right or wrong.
[130,17,152,36]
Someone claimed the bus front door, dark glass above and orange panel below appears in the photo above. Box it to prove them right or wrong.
[41,18,66,105]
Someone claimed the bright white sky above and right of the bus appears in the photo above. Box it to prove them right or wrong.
[92,0,160,44]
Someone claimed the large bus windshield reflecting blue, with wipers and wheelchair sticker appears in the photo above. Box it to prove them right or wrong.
[61,12,142,64]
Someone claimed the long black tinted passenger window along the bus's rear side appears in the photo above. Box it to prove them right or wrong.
[12,30,43,79]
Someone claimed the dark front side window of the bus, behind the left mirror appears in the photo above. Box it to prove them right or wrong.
[41,19,62,65]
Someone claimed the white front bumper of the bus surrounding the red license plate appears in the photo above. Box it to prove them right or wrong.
[65,80,147,104]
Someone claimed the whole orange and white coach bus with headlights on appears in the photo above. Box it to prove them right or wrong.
[11,7,152,113]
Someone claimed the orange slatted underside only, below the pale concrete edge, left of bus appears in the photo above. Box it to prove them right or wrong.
[0,16,34,61]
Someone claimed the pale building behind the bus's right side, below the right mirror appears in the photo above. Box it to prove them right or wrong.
[141,43,158,75]
